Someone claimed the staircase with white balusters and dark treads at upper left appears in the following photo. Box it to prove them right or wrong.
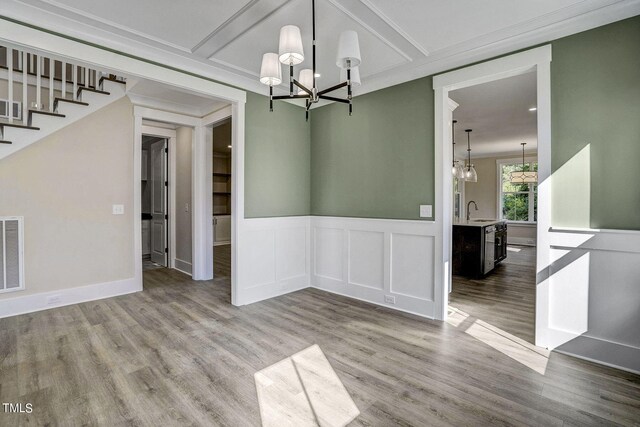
[0,46,126,159]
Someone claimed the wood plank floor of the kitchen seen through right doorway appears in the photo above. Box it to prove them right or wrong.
[449,245,536,344]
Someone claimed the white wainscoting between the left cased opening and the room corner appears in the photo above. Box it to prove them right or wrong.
[237,216,310,305]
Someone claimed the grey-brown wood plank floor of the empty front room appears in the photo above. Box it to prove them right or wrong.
[0,252,640,426]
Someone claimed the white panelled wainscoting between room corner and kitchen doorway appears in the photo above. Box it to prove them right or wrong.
[310,217,437,318]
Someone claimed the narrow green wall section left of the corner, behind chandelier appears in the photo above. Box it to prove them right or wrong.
[244,90,310,218]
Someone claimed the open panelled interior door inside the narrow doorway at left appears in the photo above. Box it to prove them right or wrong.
[149,140,168,267]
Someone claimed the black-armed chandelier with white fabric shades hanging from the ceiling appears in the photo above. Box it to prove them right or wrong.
[260,0,361,120]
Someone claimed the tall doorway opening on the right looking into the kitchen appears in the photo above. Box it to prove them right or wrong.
[449,70,538,344]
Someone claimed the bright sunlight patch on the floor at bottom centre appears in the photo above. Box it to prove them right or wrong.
[254,345,360,427]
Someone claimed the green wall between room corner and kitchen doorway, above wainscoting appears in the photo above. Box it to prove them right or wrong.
[311,77,435,219]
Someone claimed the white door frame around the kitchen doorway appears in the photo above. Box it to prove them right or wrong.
[433,45,551,347]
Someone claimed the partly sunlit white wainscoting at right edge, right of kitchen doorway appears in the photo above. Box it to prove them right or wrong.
[548,229,640,373]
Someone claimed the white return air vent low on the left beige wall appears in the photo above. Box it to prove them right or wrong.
[0,216,24,292]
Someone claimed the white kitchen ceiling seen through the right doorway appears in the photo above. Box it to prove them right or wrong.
[449,73,538,158]
